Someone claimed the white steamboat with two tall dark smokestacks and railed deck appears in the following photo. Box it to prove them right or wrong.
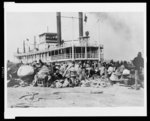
[14,12,104,63]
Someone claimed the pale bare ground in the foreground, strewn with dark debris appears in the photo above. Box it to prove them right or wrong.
[7,85,144,107]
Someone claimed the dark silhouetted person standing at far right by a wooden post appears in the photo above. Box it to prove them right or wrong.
[132,52,144,90]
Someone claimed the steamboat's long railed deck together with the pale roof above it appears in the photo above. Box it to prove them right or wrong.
[15,40,103,63]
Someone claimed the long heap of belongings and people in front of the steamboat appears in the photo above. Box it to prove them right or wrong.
[8,61,138,88]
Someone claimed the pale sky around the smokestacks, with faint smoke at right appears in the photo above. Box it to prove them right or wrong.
[5,12,144,61]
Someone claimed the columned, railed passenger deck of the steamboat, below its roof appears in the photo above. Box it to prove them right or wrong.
[16,46,104,63]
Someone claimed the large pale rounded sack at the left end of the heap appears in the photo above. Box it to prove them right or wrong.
[17,65,34,77]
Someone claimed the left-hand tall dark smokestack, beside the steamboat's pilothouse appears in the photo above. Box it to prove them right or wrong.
[57,12,61,45]
